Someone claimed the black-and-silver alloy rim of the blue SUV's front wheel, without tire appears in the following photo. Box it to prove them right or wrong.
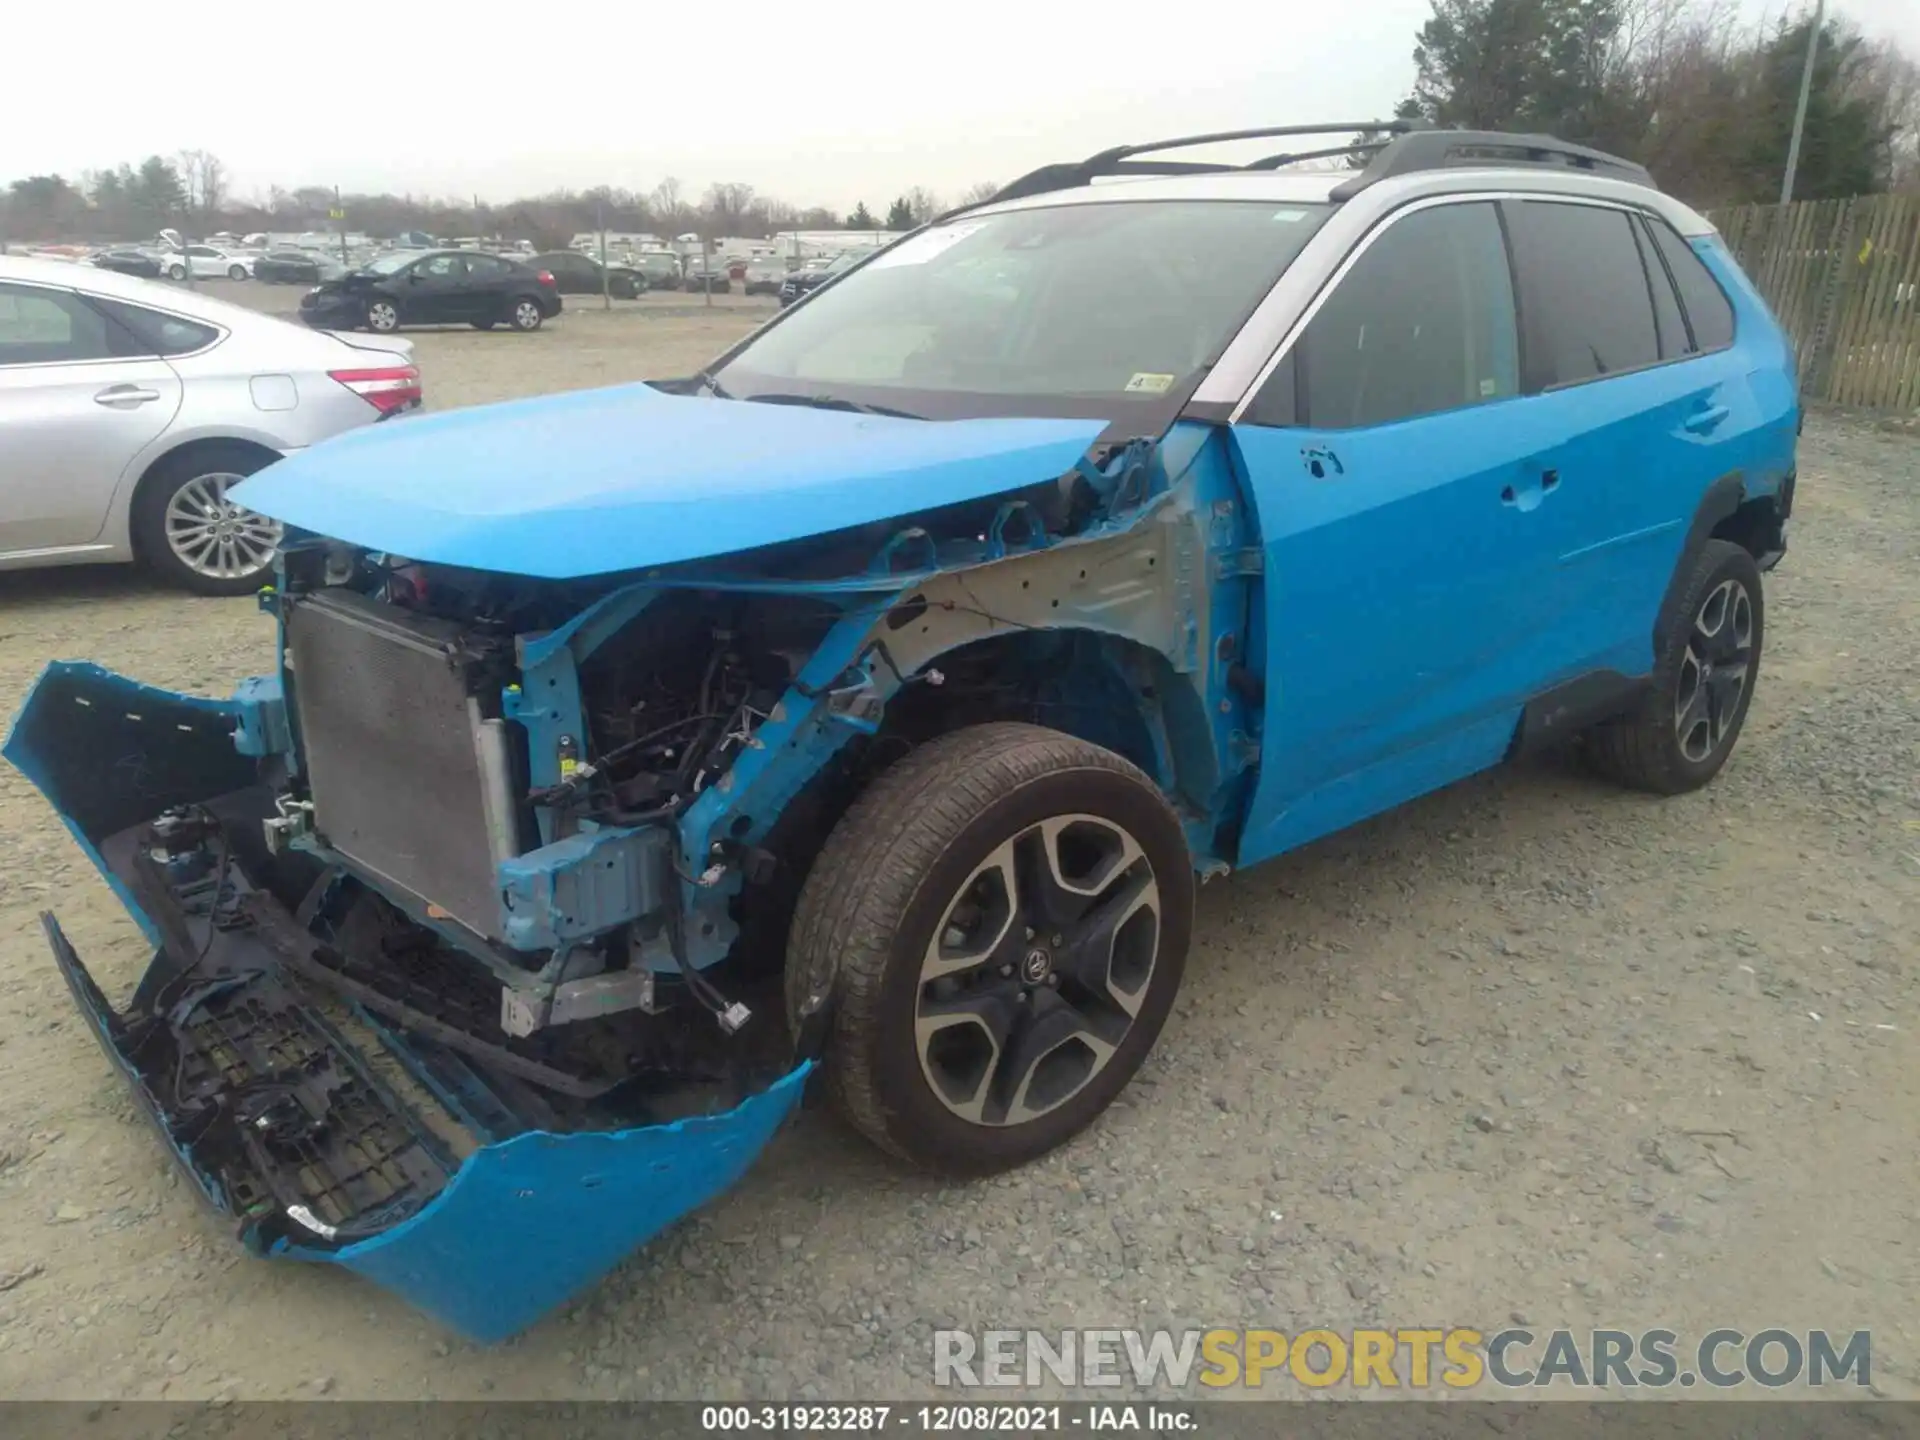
[914,814,1162,1125]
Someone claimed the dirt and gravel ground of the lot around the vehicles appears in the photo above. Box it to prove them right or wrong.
[0,288,1920,1398]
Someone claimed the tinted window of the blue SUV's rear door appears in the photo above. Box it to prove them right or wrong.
[1511,200,1661,386]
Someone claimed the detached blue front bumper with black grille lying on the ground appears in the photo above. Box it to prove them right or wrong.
[4,662,806,1340]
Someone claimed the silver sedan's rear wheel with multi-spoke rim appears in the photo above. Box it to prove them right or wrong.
[132,444,280,595]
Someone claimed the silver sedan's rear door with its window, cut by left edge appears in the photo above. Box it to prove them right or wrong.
[0,282,180,555]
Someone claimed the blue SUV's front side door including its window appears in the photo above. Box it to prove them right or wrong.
[1233,202,1551,864]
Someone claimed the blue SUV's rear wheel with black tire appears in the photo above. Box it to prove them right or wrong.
[1586,540,1766,795]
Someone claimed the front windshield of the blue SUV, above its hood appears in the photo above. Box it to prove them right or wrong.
[718,200,1329,417]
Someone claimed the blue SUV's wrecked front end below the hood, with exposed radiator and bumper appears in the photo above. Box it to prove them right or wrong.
[4,407,1258,1340]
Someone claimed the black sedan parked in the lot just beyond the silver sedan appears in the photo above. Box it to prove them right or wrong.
[300,250,561,332]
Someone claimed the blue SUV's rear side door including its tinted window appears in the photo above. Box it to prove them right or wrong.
[1503,196,1743,682]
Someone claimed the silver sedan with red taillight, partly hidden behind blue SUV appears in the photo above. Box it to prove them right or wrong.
[0,257,420,595]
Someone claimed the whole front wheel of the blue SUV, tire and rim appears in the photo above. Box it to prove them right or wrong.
[787,724,1194,1175]
